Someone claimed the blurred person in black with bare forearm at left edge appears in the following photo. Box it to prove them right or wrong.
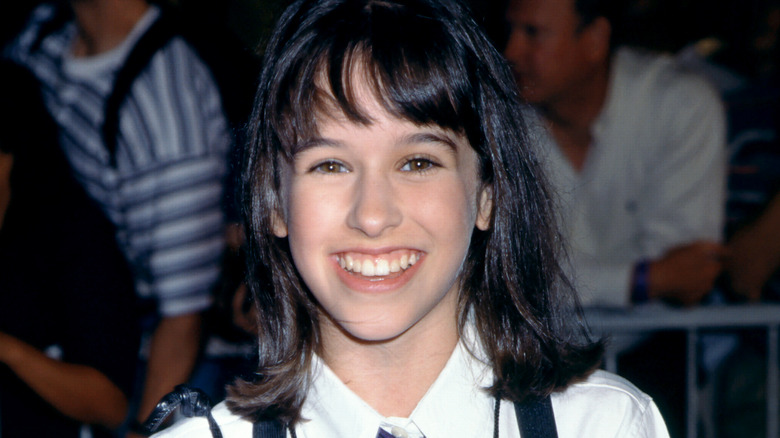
[0,62,139,438]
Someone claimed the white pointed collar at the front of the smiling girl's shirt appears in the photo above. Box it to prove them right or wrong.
[297,328,494,438]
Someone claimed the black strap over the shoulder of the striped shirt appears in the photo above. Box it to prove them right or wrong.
[102,9,176,167]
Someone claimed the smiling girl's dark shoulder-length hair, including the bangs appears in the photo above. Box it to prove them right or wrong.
[228,0,602,424]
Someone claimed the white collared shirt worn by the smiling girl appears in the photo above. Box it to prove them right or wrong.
[156,336,669,438]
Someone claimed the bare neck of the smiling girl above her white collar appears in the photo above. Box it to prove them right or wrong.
[322,310,458,417]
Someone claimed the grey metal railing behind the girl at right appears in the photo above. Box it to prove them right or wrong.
[585,304,780,438]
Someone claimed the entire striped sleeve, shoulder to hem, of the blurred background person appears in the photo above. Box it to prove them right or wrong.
[117,39,232,316]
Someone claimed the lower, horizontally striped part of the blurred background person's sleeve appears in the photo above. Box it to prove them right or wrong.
[124,158,224,316]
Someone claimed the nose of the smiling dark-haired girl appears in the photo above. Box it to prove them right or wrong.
[347,175,402,237]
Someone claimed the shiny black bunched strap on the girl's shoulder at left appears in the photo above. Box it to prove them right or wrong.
[141,385,222,438]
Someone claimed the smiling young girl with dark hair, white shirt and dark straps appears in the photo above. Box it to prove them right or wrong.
[154,0,667,438]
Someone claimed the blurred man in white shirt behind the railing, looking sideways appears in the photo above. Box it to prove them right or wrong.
[505,0,725,306]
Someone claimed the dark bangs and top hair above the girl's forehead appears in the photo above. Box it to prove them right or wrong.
[275,1,479,155]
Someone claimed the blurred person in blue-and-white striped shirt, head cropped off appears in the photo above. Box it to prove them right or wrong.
[5,0,232,432]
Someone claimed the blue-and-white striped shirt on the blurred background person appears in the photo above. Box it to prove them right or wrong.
[5,5,232,316]
